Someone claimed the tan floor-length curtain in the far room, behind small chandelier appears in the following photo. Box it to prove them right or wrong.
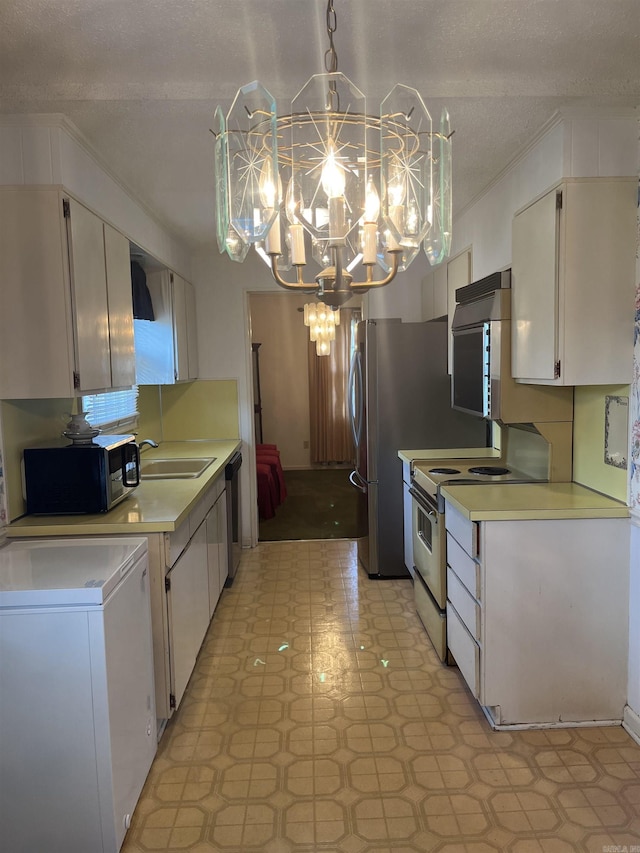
[309,308,359,462]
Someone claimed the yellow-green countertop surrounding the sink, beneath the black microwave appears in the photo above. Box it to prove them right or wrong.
[6,439,241,538]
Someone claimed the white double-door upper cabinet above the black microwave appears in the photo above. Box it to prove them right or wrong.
[0,187,133,399]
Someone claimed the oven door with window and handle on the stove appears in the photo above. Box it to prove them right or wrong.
[409,486,447,610]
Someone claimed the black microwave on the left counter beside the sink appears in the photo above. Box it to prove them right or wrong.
[23,435,140,515]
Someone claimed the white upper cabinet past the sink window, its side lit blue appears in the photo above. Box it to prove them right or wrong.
[134,269,198,385]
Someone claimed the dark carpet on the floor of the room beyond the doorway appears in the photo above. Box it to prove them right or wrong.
[258,468,359,542]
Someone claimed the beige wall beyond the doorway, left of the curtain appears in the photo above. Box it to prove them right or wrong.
[249,290,315,468]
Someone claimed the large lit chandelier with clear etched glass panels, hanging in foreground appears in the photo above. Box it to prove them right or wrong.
[213,0,452,308]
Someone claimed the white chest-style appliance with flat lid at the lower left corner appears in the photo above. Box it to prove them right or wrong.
[0,537,156,853]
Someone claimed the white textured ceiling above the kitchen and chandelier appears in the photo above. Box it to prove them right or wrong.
[0,0,640,250]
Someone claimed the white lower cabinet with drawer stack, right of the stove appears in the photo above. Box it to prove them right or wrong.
[445,502,629,728]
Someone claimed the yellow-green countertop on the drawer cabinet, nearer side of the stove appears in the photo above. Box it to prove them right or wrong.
[441,483,629,521]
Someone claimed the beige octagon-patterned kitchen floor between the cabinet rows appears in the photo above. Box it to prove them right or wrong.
[123,541,640,853]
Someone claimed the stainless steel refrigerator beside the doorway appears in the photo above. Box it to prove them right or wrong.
[348,319,488,578]
